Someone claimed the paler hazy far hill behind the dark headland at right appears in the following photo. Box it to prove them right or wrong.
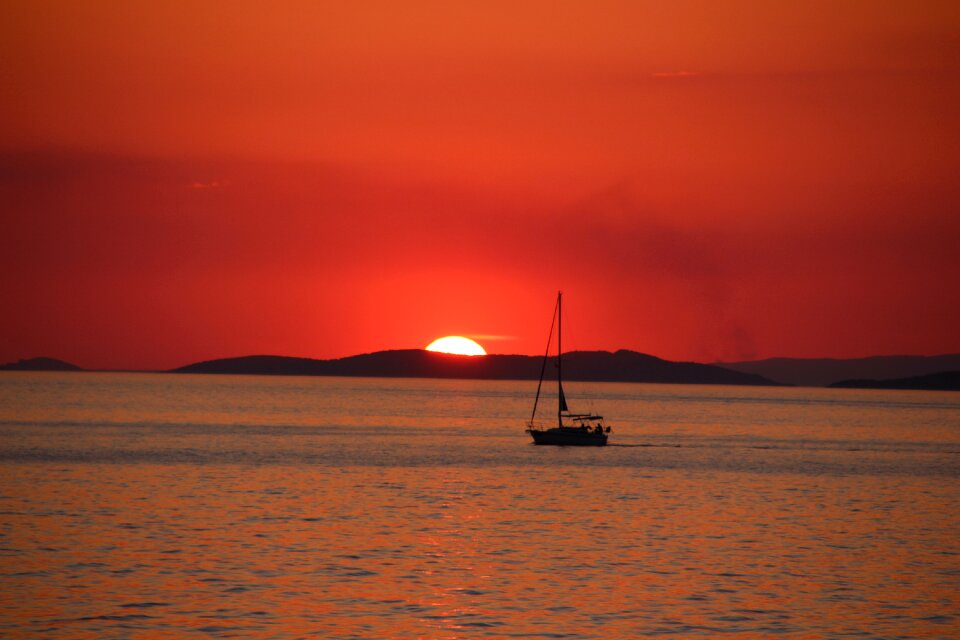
[715,354,960,387]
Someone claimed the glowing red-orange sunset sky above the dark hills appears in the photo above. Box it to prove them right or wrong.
[0,0,960,369]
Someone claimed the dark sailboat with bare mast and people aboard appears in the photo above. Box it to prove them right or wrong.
[527,291,610,447]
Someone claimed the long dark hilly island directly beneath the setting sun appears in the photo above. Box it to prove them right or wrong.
[173,349,776,385]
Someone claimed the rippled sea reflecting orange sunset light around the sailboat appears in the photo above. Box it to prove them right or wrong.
[0,372,960,639]
